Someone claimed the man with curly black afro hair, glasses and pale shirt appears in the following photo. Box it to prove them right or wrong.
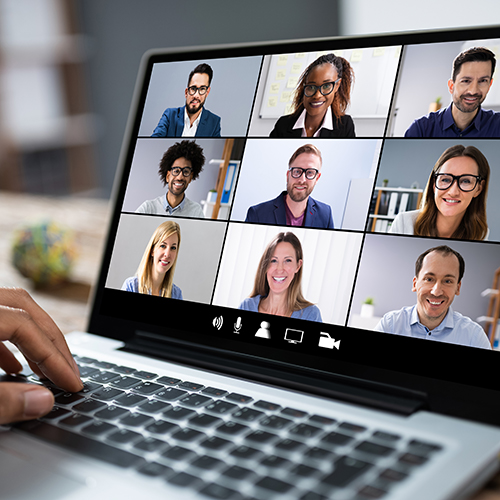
[136,141,205,218]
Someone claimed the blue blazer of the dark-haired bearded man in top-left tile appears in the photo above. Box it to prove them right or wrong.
[151,106,220,137]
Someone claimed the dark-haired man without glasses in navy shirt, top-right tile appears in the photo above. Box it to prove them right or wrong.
[405,47,500,137]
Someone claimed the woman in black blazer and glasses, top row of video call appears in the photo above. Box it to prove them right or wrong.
[270,54,355,137]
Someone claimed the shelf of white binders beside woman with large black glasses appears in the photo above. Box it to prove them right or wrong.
[369,186,423,233]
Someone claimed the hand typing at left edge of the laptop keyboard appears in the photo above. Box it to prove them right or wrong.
[0,288,83,425]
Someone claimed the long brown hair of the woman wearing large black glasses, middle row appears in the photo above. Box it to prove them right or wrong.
[414,144,490,240]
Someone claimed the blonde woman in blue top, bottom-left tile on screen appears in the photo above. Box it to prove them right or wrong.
[122,221,182,300]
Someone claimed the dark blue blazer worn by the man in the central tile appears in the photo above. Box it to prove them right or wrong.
[245,191,333,229]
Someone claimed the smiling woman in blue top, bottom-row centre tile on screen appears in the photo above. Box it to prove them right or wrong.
[239,232,322,321]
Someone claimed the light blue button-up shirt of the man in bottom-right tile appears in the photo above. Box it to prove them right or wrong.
[375,305,491,349]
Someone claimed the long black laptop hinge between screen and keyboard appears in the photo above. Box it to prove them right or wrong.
[123,332,428,415]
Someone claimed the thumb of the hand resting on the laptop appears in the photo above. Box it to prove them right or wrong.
[0,382,54,425]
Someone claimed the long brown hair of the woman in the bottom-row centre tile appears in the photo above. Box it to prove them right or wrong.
[250,232,313,314]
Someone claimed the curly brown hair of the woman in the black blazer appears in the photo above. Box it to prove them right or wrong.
[293,54,354,120]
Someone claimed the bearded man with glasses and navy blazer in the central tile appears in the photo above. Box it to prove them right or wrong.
[245,144,333,229]
